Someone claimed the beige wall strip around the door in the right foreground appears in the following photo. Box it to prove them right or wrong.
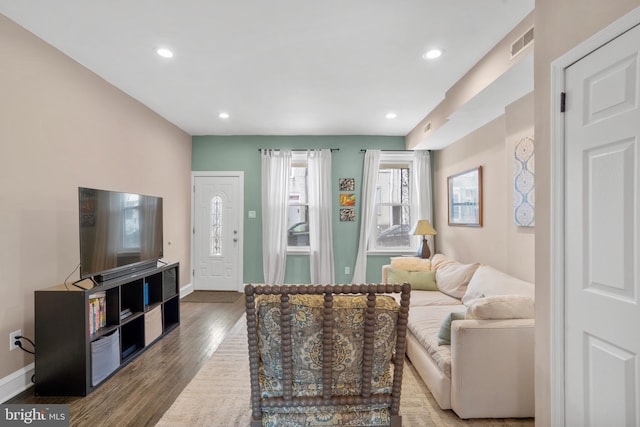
[534,0,640,426]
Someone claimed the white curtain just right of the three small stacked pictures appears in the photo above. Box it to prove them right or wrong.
[352,150,380,284]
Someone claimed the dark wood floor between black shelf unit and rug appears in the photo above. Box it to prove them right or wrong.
[5,298,244,427]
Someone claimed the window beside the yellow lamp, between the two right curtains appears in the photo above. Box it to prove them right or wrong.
[369,152,414,252]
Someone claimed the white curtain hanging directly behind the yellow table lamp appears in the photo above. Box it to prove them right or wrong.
[411,150,435,254]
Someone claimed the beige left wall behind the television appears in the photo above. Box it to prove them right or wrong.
[0,15,191,379]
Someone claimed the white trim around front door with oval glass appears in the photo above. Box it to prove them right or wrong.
[189,171,244,292]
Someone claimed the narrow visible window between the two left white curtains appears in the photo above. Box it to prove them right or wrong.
[287,152,309,252]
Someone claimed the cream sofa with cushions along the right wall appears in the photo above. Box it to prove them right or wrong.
[382,254,535,418]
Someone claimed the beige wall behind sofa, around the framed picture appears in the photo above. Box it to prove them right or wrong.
[434,94,535,282]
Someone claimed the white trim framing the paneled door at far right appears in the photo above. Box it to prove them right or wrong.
[548,7,640,427]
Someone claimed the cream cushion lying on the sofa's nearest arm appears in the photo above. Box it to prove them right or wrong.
[466,295,535,320]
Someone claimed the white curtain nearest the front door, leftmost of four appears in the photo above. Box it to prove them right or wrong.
[261,150,291,285]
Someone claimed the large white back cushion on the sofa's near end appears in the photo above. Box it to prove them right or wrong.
[462,265,535,306]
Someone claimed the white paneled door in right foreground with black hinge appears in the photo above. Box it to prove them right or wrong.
[564,23,640,427]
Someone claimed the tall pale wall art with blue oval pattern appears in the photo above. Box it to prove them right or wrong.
[513,136,536,227]
